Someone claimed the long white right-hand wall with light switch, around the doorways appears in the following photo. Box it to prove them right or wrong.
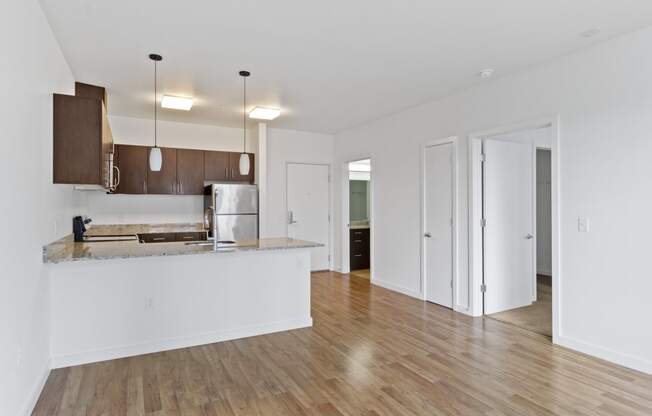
[334,25,652,372]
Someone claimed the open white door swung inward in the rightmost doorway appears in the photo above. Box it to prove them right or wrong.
[483,139,534,314]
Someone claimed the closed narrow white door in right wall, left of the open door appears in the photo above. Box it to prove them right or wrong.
[424,143,453,308]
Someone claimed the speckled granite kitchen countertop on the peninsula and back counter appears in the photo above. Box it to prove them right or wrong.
[43,224,322,263]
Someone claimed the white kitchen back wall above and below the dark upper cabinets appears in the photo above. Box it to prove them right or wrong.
[84,116,258,224]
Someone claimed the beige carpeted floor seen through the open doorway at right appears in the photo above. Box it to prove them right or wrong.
[487,275,552,338]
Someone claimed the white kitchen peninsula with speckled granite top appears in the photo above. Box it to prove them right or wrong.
[44,232,318,368]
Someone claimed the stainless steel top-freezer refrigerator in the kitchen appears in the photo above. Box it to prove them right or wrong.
[204,184,258,242]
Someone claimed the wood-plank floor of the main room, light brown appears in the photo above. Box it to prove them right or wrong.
[34,272,652,416]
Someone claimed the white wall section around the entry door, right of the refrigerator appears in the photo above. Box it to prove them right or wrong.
[266,128,333,239]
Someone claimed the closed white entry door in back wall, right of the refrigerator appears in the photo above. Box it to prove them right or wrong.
[287,163,330,270]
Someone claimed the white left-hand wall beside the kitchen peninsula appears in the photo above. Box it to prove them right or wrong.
[0,0,81,415]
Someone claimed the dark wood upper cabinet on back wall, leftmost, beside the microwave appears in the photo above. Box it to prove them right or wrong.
[114,145,149,194]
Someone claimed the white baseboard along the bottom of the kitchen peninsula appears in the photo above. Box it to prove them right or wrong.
[52,317,312,368]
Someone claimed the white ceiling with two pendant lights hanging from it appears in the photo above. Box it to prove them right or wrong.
[41,0,652,133]
